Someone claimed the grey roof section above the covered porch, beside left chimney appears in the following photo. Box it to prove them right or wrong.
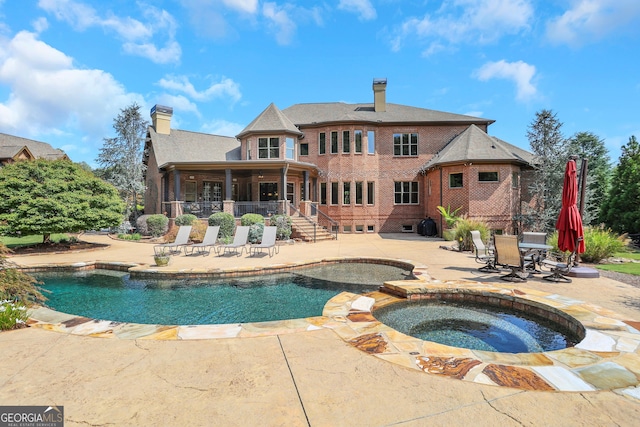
[148,126,240,168]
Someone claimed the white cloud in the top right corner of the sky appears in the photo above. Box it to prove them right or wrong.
[547,0,640,45]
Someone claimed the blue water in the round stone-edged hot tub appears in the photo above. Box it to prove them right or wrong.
[374,300,579,353]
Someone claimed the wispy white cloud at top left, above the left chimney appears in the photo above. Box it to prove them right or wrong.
[38,0,182,64]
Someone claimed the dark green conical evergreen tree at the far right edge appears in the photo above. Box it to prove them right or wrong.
[602,136,640,233]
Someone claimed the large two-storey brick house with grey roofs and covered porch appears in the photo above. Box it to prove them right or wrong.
[144,79,533,233]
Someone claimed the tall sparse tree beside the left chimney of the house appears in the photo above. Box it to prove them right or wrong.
[97,103,149,221]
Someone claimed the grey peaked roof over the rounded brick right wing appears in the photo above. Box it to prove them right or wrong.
[422,125,534,170]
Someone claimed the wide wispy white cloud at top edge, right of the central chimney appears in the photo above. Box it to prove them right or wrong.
[391,0,533,54]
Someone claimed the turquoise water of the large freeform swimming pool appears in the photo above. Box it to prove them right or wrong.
[36,263,407,325]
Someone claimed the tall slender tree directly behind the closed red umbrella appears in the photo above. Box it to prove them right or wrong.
[527,110,569,231]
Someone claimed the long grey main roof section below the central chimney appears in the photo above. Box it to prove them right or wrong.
[282,102,495,126]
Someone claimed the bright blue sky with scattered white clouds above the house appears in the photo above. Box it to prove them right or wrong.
[0,0,640,167]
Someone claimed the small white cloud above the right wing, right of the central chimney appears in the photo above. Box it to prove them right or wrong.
[474,60,537,101]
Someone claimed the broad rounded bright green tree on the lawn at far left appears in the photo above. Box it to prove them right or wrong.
[0,159,124,243]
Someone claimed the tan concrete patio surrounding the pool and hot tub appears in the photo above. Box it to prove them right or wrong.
[0,234,640,426]
